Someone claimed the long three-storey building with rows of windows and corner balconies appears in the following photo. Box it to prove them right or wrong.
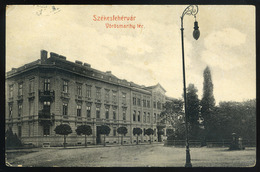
[6,50,173,146]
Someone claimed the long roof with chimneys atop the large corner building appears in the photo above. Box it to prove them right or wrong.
[6,50,162,93]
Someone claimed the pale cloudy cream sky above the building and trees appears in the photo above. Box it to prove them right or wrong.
[6,5,256,103]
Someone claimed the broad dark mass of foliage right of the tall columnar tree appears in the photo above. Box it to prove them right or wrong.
[207,100,256,140]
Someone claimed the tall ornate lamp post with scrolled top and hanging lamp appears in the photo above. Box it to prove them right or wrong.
[181,5,200,167]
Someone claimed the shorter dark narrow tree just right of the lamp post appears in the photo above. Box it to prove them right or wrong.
[186,84,200,139]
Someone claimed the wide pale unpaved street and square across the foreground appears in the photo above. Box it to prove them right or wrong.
[7,144,256,167]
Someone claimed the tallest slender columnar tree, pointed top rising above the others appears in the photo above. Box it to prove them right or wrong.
[201,66,215,145]
